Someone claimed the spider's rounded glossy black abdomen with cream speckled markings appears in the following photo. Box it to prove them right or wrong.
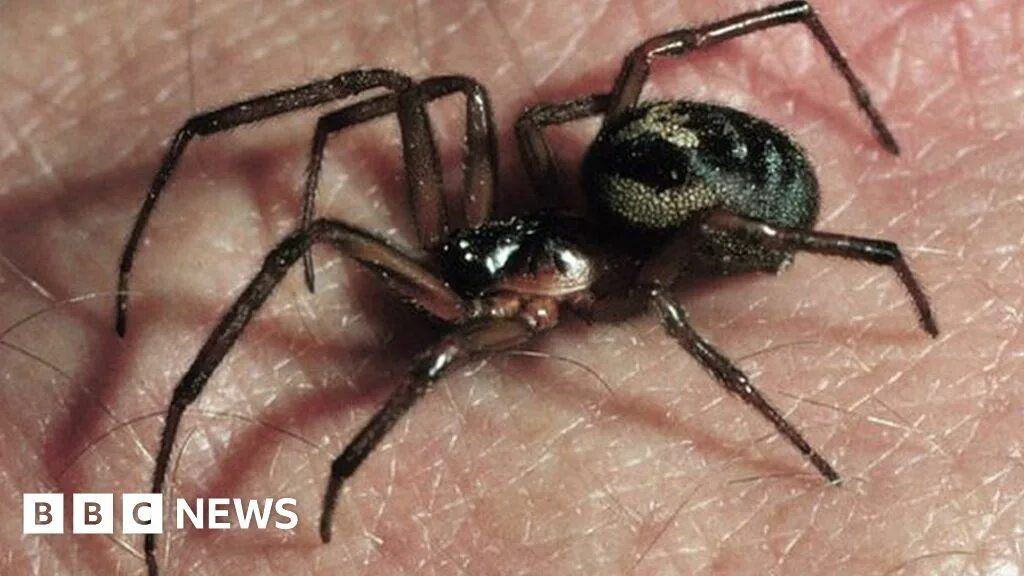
[582,100,818,273]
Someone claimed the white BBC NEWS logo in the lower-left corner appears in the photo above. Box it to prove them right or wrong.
[23,492,299,534]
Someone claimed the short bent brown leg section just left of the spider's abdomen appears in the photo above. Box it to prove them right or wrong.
[515,94,608,198]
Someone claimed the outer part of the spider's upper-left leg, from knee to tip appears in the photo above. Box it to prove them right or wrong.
[115,69,411,336]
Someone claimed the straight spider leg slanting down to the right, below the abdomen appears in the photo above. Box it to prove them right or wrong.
[649,288,842,484]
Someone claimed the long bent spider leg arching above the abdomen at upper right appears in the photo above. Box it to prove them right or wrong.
[604,1,899,154]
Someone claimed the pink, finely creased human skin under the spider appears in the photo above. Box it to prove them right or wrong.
[0,0,1024,576]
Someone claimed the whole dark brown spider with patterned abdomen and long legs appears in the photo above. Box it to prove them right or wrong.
[116,1,938,575]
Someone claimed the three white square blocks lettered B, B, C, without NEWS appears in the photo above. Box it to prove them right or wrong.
[22,493,164,534]
